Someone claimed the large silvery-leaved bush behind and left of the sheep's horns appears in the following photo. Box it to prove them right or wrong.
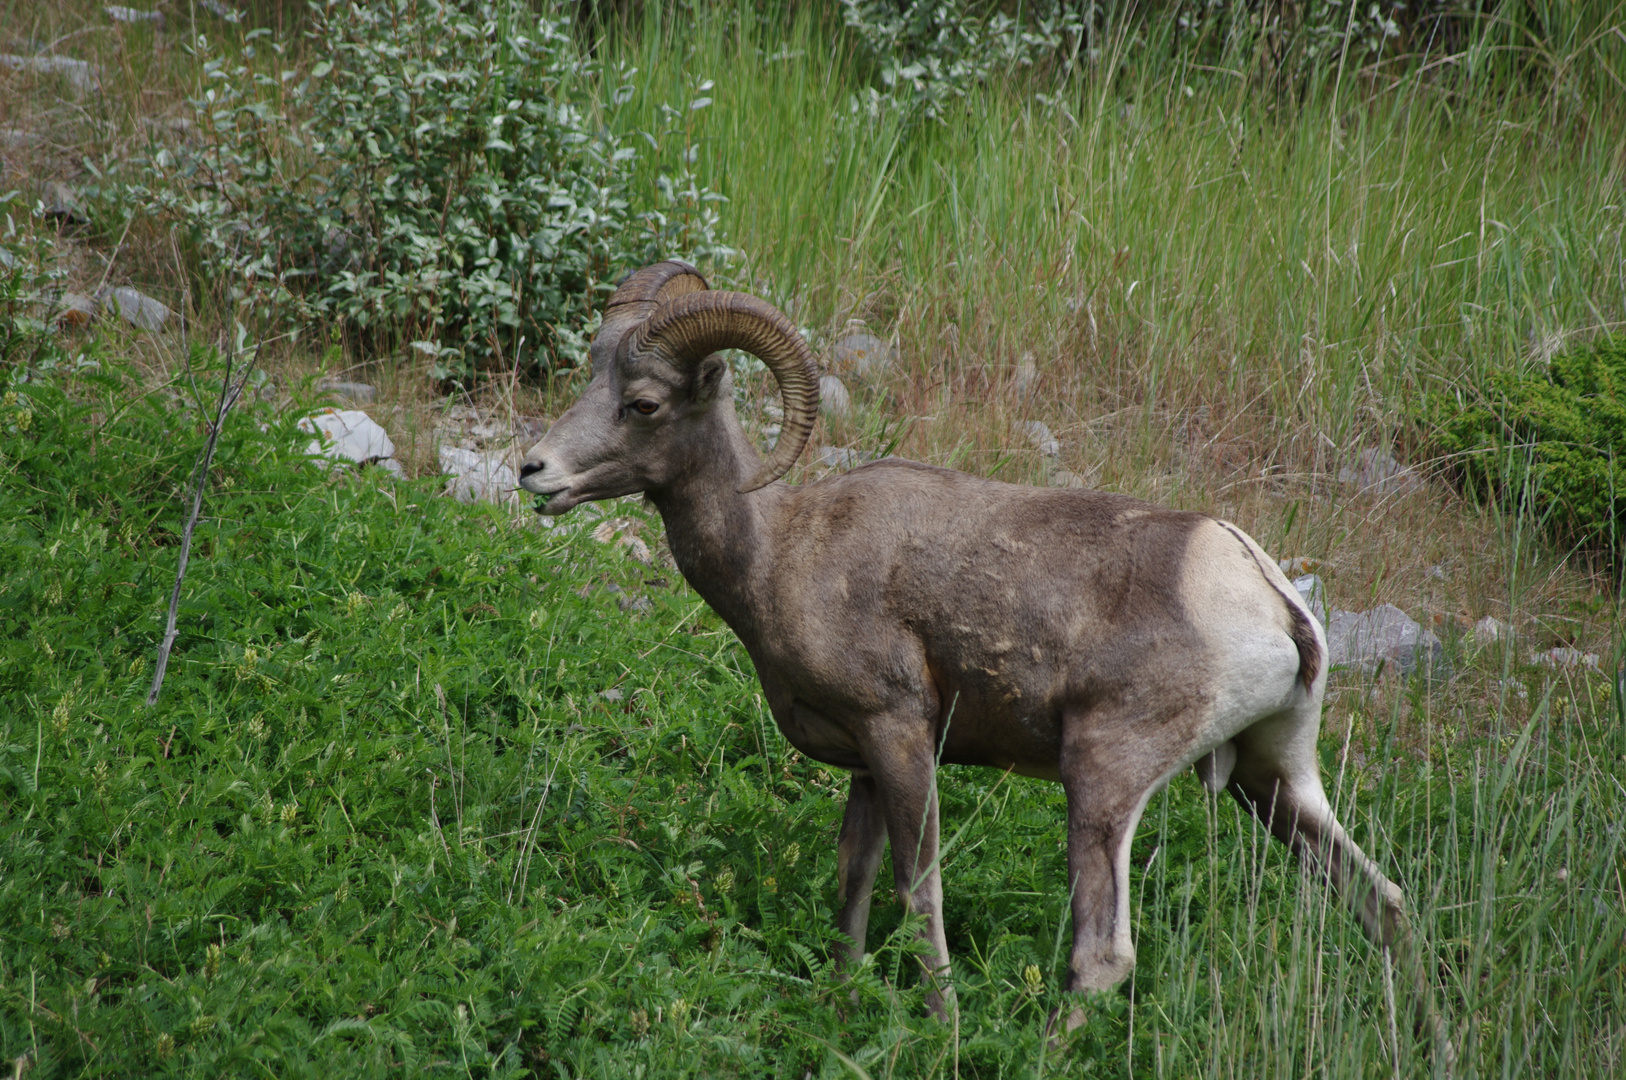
[130,0,722,376]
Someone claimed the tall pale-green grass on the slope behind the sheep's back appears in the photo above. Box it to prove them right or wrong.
[623,7,1626,497]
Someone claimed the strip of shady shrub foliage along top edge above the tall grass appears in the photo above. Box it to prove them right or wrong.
[842,0,1621,119]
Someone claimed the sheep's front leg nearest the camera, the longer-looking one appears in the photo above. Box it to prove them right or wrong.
[865,724,953,1018]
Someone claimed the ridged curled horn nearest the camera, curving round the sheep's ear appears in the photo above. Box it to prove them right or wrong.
[628,293,818,494]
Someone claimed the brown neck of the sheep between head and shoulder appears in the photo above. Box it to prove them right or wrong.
[649,402,779,642]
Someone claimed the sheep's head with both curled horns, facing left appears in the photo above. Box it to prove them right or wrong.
[520,260,818,514]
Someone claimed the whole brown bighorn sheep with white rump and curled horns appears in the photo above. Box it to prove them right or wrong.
[520,262,1430,1040]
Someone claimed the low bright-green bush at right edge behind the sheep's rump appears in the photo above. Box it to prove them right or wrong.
[1429,337,1626,560]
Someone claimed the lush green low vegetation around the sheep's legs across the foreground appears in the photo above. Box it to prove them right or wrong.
[0,356,1626,1077]
